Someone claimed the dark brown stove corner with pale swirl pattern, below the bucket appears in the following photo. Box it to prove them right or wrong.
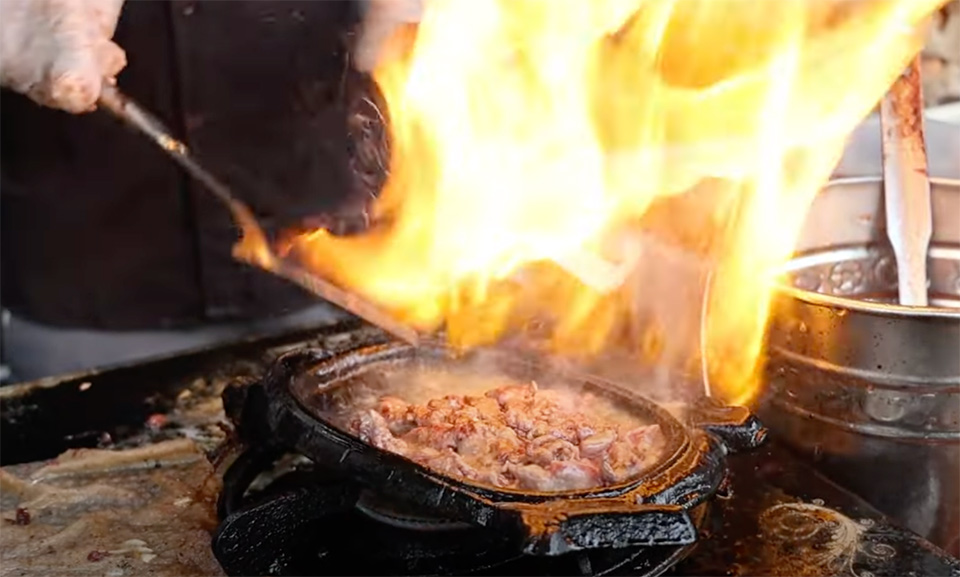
[667,443,960,577]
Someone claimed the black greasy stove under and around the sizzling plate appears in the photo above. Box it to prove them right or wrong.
[0,322,960,577]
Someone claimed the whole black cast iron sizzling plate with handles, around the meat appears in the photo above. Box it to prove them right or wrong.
[241,344,765,555]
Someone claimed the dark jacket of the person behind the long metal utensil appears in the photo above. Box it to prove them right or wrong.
[0,0,372,329]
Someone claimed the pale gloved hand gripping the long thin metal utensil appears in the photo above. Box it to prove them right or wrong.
[0,0,127,113]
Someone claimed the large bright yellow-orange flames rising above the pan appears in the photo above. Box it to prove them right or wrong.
[264,0,943,403]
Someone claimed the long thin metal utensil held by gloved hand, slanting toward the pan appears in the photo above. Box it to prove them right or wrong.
[98,82,420,346]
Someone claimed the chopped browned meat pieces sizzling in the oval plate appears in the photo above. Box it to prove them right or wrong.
[347,383,665,491]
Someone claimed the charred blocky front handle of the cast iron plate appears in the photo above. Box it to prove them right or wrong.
[520,499,697,556]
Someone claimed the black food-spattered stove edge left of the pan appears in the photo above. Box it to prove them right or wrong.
[0,320,372,466]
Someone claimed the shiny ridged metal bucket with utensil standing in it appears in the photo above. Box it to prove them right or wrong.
[761,178,960,556]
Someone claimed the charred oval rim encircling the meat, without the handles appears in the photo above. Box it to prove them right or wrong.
[267,343,692,504]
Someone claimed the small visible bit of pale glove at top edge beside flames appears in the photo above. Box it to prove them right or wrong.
[354,0,426,72]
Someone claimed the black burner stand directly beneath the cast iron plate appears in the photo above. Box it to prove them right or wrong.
[213,454,704,576]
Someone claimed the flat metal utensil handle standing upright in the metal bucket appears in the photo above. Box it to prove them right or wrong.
[880,56,933,306]
